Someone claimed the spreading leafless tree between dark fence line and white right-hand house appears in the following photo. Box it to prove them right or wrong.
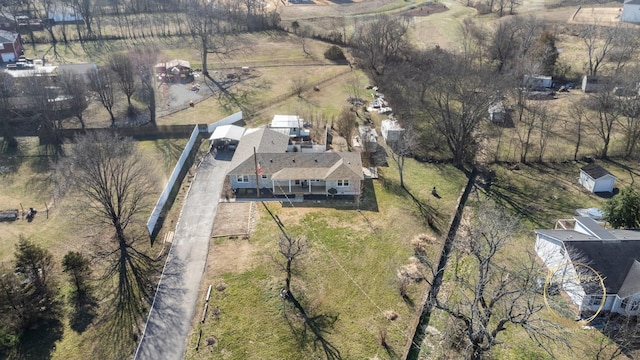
[416,201,557,360]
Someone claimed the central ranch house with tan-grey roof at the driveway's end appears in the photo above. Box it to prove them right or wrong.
[228,128,364,197]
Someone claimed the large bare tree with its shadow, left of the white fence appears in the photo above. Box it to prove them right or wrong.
[54,132,155,348]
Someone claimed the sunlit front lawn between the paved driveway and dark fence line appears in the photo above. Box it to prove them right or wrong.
[182,159,465,359]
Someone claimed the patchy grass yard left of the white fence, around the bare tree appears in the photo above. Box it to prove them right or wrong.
[0,138,186,359]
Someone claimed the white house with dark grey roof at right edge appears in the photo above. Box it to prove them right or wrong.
[535,217,640,315]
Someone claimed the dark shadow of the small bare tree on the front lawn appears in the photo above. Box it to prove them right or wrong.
[283,293,342,360]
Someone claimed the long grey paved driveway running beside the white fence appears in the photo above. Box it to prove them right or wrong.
[134,153,231,360]
